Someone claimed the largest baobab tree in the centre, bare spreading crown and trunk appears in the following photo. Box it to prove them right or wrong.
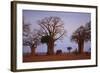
[38,16,65,54]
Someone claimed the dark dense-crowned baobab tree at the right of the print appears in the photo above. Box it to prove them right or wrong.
[71,22,91,53]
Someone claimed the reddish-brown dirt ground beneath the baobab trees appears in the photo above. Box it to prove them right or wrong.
[23,53,91,62]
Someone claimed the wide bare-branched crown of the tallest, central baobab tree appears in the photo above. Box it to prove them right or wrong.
[38,16,65,41]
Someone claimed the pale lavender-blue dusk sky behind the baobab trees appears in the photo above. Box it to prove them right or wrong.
[23,10,91,52]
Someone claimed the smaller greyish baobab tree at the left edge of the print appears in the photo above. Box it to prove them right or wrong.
[23,24,40,55]
